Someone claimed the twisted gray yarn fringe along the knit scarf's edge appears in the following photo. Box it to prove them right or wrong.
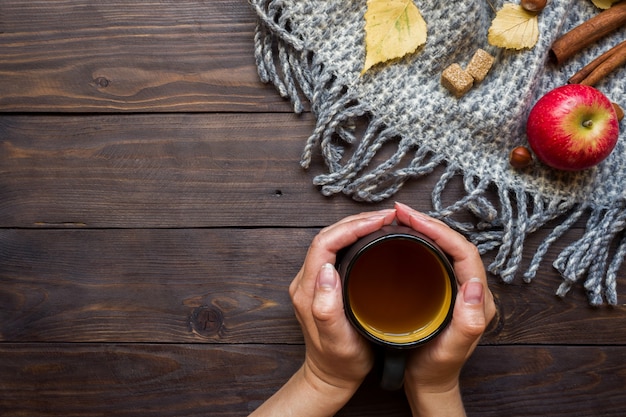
[251,0,626,306]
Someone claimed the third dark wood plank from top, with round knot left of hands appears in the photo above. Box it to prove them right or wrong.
[0,228,626,345]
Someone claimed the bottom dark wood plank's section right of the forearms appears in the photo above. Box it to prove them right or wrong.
[461,346,626,417]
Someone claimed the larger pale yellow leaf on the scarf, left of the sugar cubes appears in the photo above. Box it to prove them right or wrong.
[361,0,426,75]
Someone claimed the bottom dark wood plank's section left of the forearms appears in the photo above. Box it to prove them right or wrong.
[0,344,302,417]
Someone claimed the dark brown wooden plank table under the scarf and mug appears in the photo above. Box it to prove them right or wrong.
[0,0,626,417]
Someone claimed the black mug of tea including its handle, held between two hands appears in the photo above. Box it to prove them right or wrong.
[336,225,457,390]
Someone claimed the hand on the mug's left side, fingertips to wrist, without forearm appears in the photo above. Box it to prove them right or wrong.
[289,209,395,393]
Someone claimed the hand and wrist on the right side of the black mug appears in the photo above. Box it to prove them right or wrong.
[396,203,496,417]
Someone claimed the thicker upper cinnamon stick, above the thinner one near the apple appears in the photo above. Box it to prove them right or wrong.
[550,1,626,64]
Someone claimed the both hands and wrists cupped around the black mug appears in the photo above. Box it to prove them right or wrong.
[249,203,496,417]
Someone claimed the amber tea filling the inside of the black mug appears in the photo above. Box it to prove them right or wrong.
[344,228,454,344]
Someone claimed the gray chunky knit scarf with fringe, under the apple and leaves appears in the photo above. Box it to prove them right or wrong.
[250,0,626,305]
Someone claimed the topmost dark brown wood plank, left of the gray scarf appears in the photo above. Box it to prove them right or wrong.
[0,0,291,112]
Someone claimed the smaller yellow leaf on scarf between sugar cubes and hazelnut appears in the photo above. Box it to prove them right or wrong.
[487,3,539,49]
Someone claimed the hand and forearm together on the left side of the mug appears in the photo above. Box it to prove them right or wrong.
[252,209,395,417]
